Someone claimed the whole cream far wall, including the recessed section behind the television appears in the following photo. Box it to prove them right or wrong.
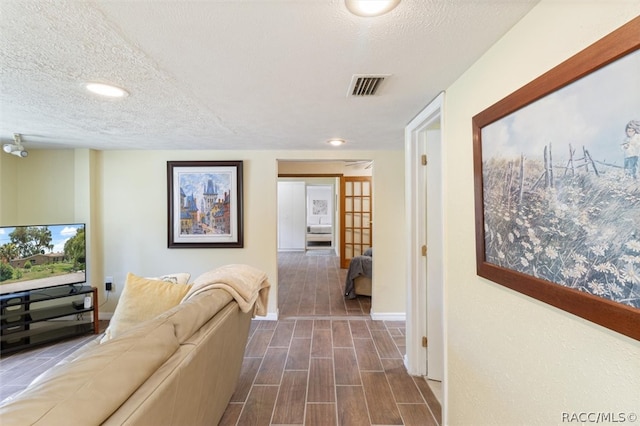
[0,146,405,315]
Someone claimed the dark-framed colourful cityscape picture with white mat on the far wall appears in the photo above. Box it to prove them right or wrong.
[167,161,244,248]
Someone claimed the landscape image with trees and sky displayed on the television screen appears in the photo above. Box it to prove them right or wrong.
[0,226,85,284]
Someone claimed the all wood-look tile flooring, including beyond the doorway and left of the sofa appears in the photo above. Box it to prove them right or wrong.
[0,252,442,426]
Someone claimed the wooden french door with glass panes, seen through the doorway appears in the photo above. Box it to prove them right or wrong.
[340,176,373,269]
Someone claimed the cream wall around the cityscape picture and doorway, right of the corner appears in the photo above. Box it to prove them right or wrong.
[104,151,405,313]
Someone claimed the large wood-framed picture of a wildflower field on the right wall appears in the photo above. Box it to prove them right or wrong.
[472,17,640,340]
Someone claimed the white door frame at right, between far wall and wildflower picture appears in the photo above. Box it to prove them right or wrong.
[405,92,447,386]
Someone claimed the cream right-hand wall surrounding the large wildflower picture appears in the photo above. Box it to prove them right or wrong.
[443,0,640,425]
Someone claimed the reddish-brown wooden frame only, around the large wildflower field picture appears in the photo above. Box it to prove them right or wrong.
[472,17,640,340]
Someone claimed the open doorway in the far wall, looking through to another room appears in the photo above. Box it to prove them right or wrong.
[277,160,372,317]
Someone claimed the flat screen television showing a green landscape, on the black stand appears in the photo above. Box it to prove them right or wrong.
[0,223,87,294]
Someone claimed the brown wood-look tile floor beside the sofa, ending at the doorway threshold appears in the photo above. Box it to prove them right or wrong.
[220,317,441,426]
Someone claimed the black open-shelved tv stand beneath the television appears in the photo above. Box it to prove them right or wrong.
[0,285,99,355]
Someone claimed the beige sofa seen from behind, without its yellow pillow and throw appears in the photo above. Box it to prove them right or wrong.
[0,288,253,426]
